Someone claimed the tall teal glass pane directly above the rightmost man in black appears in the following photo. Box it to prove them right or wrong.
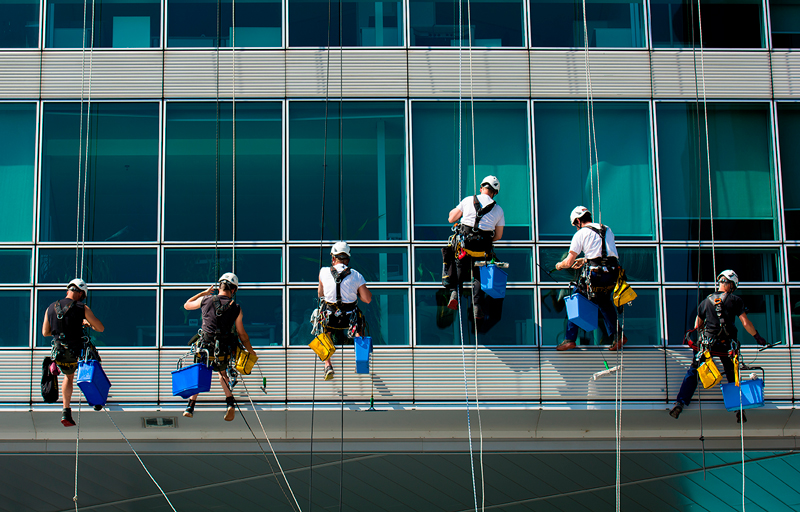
[656,102,778,240]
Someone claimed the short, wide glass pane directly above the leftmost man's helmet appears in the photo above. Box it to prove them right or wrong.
[38,249,158,284]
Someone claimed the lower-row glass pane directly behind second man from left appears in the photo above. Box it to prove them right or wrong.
[162,289,282,350]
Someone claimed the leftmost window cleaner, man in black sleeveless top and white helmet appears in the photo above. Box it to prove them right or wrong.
[42,278,105,427]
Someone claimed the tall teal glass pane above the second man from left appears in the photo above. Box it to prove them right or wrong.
[164,102,284,241]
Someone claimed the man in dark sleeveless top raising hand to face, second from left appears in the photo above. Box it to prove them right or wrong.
[183,272,255,421]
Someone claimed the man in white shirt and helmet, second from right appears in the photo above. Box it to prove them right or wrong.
[556,206,628,350]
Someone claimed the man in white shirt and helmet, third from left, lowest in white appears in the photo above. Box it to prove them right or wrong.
[317,242,372,380]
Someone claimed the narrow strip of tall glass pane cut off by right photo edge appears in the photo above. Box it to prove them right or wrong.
[776,104,800,240]
